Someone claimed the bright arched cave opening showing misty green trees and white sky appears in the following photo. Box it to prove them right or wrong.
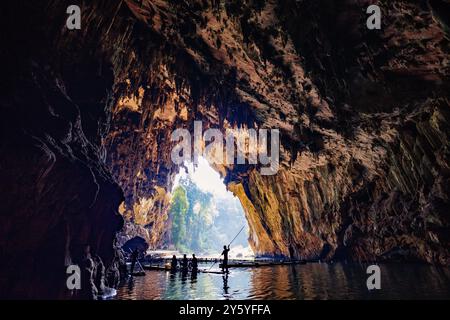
[167,157,254,259]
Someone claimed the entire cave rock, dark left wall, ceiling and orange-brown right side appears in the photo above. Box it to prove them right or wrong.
[0,0,450,298]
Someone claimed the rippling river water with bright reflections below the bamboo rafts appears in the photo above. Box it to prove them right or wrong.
[116,263,450,300]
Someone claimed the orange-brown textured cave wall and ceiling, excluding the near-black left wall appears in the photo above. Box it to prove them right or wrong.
[100,1,449,264]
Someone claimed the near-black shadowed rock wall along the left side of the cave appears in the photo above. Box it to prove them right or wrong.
[0,2,124,299]
